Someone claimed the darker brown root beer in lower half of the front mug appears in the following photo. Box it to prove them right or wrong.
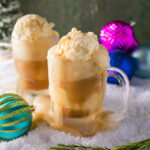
[60,77,104,118]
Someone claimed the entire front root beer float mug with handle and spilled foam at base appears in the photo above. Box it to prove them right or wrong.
[34,28,129,136]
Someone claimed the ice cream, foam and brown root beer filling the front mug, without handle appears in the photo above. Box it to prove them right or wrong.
[48,28,110,117]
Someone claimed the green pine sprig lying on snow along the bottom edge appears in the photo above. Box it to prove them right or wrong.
[50,139,150,150]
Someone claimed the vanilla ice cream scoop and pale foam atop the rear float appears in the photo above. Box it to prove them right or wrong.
[11,14,59,61]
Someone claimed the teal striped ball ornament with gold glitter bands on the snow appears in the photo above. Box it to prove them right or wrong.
[0,93,32,140]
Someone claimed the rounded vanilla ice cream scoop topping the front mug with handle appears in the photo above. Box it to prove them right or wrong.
[57,28,99,61]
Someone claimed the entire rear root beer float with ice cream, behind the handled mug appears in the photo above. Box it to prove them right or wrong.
[11,14,59,90]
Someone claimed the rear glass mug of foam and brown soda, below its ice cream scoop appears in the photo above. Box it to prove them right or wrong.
[11,37,59,96]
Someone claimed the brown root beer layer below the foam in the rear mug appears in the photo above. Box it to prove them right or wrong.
[14,58,48,90]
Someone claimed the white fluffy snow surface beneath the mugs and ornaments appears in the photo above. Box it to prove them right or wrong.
[0,59,150,150]
